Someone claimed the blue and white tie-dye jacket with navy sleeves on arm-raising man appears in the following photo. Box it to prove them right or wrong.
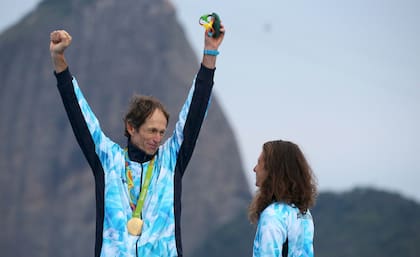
[55,65,214,257]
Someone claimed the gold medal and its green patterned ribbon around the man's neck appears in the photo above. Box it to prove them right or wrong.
[124,149,155,236]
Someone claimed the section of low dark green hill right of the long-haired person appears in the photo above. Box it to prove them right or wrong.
[313,188,420,257]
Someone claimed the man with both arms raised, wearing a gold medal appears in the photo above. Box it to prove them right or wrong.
[50,21,224,254]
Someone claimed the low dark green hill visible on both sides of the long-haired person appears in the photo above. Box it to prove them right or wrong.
[192,188,420,257]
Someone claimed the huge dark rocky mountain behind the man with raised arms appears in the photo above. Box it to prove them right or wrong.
[0,0,250,257]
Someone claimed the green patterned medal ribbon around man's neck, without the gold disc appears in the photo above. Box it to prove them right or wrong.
[124,148,155,218]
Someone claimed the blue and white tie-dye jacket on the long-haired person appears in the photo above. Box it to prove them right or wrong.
[253,202,314,257]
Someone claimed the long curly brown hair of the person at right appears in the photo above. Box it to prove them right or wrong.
[248,140,317,224]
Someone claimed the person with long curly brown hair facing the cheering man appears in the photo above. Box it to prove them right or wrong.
[249,140,316,257]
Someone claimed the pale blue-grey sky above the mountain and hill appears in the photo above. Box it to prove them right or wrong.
[0,0,420,202]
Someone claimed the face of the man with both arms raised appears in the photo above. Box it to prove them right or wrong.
[127,109,168,155]
